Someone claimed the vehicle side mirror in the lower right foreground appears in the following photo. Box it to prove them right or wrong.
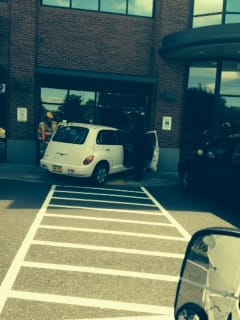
[174,228,240,320]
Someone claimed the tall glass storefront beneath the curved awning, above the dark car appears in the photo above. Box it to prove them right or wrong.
[181,61,240,157]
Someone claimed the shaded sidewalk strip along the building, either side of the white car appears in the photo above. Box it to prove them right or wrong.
[0,163,178,186]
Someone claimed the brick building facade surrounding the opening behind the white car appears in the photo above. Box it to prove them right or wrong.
[0,0,240,170]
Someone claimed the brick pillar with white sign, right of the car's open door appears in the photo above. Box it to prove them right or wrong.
[153,0,192,148]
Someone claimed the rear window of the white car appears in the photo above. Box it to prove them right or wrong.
[52,126,89,144]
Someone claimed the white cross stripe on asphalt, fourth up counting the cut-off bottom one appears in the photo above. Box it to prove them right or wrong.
[32,240,184,259]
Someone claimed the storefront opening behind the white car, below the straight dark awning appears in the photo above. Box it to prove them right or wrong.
[37,75,154,158]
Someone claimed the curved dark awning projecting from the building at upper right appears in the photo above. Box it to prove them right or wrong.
[159,23,240,60]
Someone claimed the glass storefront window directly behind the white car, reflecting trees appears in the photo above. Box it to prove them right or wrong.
[37,87,149,158]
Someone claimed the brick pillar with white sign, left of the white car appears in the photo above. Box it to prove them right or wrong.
[7,0,36,140]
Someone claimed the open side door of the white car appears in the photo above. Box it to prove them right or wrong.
[146,131,159,171]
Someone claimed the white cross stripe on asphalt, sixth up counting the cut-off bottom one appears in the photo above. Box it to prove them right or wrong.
[44,213,175,228]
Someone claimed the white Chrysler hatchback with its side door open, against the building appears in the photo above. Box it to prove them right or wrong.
[40,123,159,184]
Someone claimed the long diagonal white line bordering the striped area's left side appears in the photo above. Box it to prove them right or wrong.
[0,186,55,314]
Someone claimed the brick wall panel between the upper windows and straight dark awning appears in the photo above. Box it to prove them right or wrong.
[38,7,154,75]
